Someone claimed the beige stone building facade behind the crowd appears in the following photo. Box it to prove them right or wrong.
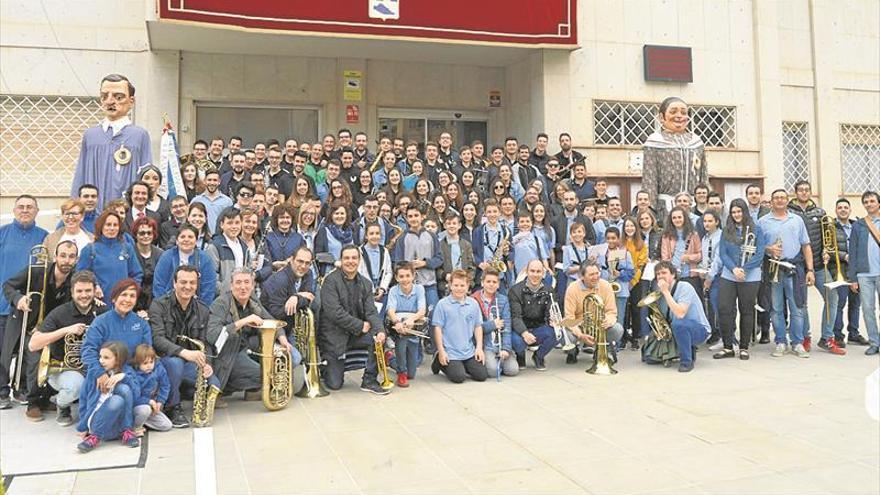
[0,0,880,221]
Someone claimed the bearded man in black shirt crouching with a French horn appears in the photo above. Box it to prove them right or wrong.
[28,270,108,426]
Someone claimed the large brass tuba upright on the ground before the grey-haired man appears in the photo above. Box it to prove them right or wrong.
[248,320,293,411]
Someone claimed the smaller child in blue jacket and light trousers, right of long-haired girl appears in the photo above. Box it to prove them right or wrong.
[132,344,172,436]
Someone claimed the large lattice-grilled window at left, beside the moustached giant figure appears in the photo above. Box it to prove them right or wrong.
[0,95,104,196]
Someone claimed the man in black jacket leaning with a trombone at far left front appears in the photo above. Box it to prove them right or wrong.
[0,241,79,421]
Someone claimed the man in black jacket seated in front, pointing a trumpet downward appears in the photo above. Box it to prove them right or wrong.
[318,245,388,395]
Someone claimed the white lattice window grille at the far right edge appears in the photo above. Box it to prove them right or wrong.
[840,124,880,194]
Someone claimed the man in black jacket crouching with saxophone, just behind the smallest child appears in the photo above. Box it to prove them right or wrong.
[149,265,219,428]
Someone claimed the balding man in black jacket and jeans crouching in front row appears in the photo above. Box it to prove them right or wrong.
[507,259,556,371]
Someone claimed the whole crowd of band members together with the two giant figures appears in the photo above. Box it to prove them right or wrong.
[0,75,880,458]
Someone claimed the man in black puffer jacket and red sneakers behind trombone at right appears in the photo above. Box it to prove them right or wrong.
[788,180,832,354]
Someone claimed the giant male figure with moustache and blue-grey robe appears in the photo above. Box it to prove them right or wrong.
[70,74,153,205]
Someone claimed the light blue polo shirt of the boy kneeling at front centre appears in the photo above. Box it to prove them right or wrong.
[431,296,483,361]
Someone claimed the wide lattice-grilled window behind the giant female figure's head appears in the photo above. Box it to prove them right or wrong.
[593,100,736,149]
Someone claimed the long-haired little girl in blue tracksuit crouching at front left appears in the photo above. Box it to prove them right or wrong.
[76,341,140,453]
